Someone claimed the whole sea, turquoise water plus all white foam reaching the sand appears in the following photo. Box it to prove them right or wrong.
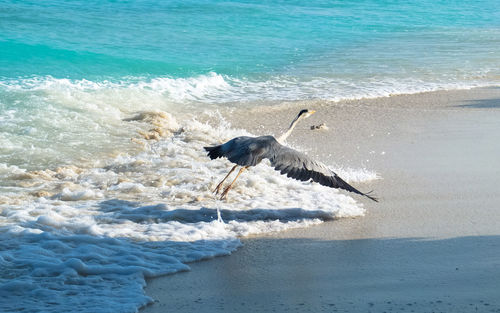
[0,0,500,312]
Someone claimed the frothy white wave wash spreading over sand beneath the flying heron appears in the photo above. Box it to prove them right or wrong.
[0,112,373,312]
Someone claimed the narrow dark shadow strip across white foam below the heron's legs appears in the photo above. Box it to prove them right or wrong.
[95,199,333,223]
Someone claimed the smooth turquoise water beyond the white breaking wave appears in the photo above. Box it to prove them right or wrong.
[0,0,500,80]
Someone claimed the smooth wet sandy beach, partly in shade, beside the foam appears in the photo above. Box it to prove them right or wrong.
[141,88,500,313]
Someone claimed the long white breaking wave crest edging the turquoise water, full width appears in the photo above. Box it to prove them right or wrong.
[0,72,499,105]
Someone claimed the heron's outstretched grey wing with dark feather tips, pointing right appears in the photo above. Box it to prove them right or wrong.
[262,140,378,202]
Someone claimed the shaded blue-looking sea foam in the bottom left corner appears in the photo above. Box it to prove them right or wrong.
[0,230,240,313]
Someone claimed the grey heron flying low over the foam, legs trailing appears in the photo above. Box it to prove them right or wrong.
[204,110,378,202]
